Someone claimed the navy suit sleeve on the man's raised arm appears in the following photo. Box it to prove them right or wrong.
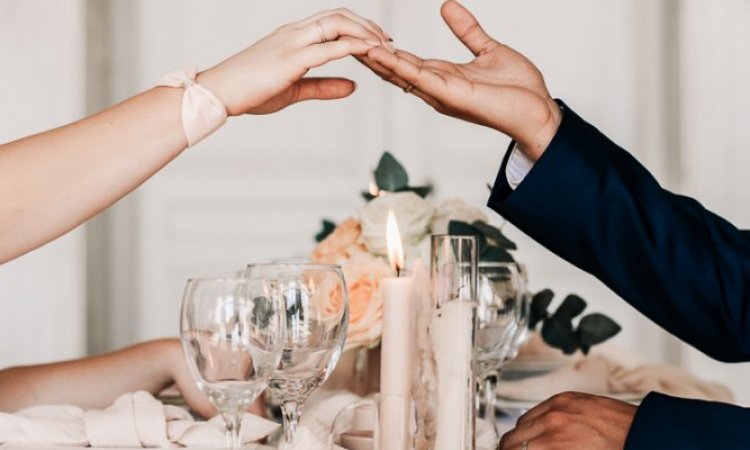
[489,101,750,361]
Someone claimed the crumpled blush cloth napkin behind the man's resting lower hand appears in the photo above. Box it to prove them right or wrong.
[497,355,733,402]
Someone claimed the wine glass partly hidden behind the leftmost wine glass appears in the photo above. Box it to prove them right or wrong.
[245,263,349,446]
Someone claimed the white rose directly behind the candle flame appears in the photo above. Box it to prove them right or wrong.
[360,192,434,255]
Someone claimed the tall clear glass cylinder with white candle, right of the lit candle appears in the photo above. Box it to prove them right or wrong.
[430,235,477,450]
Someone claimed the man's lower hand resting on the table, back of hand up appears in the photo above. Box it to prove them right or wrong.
[499,392,637,450]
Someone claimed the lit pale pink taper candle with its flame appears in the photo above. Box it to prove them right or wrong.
[380,211,414,450]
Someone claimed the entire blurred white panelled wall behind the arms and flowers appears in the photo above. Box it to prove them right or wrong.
[0,0,750,405]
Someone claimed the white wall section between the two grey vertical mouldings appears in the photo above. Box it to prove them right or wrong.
[95,0,669,368]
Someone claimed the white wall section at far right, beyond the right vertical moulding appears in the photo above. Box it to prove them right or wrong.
[680,0,750,405]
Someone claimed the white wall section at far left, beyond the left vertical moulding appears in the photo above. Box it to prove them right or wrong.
[0,0,86,367]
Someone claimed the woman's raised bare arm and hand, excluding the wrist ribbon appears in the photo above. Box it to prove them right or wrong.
[0,10,390,263]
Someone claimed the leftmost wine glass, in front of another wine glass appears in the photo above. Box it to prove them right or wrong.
[180,278,284,450]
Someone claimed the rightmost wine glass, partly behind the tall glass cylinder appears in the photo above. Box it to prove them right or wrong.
[474,262,523,423]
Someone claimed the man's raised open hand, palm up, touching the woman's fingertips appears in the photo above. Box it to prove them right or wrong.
[360,0,562,161]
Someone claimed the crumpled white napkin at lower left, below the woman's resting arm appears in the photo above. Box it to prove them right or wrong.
[0,391,278,448]
